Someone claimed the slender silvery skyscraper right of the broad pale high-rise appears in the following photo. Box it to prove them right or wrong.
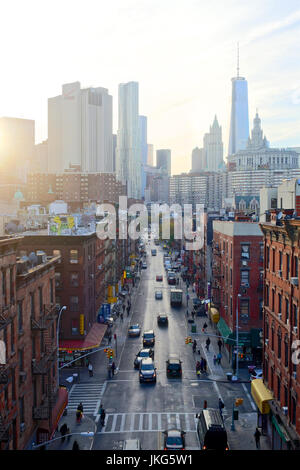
[116,82,141,199]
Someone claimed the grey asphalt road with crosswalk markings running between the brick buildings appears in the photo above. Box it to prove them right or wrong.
[93,242,253,450]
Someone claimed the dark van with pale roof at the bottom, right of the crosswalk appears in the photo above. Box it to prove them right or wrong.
[196,408,228,450]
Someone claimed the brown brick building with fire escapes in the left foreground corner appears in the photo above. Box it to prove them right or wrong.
[0,237,67,450]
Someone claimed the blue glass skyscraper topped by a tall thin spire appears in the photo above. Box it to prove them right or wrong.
[228,47,249,155]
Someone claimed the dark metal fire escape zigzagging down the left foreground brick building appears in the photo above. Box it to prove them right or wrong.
[31,305,58,427]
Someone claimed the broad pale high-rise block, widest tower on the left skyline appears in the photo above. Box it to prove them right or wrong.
[48,82,113,173]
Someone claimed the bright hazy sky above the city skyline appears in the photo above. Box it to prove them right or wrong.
[0,0,300,174]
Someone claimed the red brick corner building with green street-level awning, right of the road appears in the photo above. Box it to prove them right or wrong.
[211,216,263,368]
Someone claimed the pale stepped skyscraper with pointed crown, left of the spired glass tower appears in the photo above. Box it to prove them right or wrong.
[203,116,224,171]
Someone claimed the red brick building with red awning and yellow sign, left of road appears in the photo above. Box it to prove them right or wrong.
[17,233,106,364]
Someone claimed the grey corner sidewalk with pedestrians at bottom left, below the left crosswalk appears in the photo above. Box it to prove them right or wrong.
[47,412,97,450]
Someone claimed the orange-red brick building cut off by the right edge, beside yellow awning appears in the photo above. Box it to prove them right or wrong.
[261,209,300,449]
